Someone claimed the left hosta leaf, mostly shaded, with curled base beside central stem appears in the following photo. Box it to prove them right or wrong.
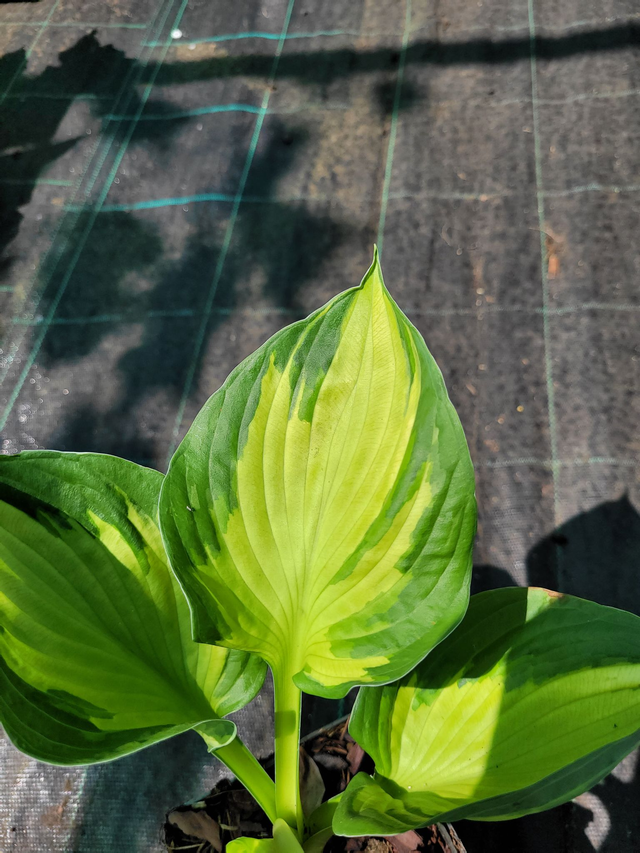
[0,451,264,764]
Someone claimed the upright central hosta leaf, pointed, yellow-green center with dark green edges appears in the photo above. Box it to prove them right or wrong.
[160,253,475,697]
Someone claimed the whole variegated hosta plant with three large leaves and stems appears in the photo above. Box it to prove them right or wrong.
[0,257,640,853]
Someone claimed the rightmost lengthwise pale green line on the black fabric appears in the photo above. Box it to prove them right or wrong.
[527,0,564,564]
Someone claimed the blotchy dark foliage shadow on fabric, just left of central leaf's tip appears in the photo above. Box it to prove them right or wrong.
[42,112,349,461]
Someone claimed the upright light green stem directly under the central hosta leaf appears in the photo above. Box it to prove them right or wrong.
[273,667,304,839]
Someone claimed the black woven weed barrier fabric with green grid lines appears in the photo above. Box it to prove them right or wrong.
[0,0,640,853]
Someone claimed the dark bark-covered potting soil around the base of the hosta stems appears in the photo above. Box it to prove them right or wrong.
[165,721,466,853]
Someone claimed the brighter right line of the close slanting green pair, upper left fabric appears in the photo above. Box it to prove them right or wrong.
[0,0,189,429]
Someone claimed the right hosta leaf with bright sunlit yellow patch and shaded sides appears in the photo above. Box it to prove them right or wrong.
[333,588,640,835]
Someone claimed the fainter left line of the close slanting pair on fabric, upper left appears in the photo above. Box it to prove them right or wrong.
[0,0,180,370]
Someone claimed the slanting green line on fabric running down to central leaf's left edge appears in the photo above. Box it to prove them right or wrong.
[167,0,295,463]
